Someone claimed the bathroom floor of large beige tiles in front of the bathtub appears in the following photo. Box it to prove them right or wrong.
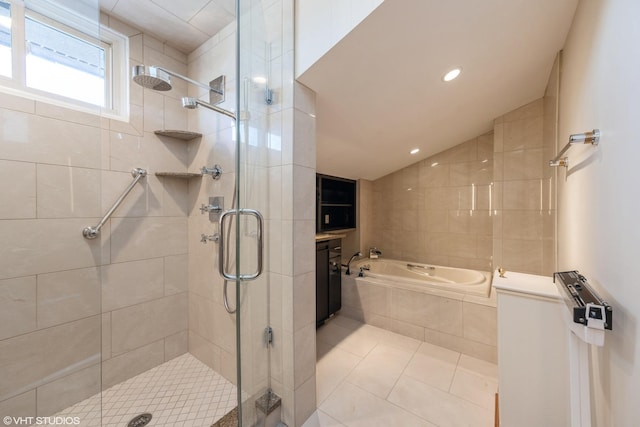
[303,315,498,427]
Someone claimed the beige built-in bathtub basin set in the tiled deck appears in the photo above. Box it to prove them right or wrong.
[351,258,491,298]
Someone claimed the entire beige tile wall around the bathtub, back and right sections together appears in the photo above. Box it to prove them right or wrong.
[362,93,557,275]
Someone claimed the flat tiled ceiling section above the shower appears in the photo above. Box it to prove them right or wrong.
[99,0,236,53]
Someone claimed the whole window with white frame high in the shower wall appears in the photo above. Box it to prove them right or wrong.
[0,0,129,120]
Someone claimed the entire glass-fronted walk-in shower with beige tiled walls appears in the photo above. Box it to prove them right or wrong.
[0,0,315,426]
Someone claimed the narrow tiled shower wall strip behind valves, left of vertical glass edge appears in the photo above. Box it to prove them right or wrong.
[187,22,236,384]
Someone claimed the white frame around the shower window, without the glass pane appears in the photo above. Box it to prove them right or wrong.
[0,0,129,121]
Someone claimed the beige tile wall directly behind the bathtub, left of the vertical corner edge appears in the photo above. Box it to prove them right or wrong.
[363,133,493,270]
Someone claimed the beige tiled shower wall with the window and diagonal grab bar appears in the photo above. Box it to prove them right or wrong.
[0,15,188,422]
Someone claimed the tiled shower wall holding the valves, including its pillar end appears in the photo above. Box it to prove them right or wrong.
[188,0,315,426]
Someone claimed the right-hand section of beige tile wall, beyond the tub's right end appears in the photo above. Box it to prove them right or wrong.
[493,98,556,275]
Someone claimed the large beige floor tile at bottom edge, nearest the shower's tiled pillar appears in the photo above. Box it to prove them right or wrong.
[320,383,433,427]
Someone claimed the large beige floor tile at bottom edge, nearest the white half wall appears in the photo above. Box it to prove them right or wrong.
[388,376,493,427]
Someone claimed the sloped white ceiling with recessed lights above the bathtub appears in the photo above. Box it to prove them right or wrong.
[299,0,578,180]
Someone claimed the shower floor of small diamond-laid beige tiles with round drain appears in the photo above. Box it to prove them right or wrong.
[42,353,237,427]
